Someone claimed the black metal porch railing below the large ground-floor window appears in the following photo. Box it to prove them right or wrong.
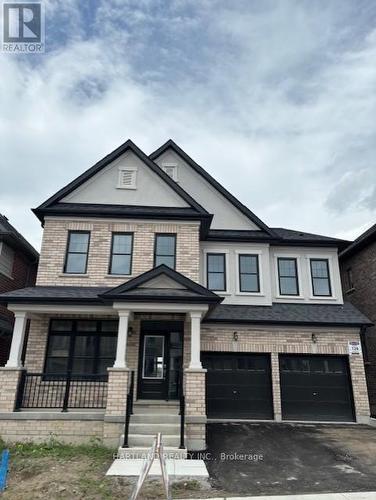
[16,370,108,411]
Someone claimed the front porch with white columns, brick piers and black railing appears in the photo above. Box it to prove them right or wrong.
[0,303,207,450]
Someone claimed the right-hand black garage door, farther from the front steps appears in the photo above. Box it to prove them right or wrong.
[279,355,354,422]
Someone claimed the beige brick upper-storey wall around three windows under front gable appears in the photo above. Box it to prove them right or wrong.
[37,218,199,287]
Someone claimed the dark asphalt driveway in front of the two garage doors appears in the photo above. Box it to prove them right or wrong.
[203,423,376,496]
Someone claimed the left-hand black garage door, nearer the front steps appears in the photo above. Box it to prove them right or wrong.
[202,353,273,419]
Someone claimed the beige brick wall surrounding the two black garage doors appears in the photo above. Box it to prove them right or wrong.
[201,324,370,422]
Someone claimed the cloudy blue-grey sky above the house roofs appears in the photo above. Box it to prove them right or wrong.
[0,0,376,247]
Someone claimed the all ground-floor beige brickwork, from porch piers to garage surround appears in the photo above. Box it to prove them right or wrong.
[0,314,369,449]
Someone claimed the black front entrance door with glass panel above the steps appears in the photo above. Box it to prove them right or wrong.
[138,321,183,400]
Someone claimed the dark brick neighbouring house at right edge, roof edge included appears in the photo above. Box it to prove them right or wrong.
[339,224,376,416]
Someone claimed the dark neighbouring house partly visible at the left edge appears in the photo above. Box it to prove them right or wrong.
[0,214,39,366]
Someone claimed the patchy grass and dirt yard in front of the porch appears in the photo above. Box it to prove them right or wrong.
[0,441,220,500]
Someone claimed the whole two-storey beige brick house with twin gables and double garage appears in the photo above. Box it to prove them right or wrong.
[0,140,370,452]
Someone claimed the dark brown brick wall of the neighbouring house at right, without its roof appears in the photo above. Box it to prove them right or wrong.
[340,242,376,416]
